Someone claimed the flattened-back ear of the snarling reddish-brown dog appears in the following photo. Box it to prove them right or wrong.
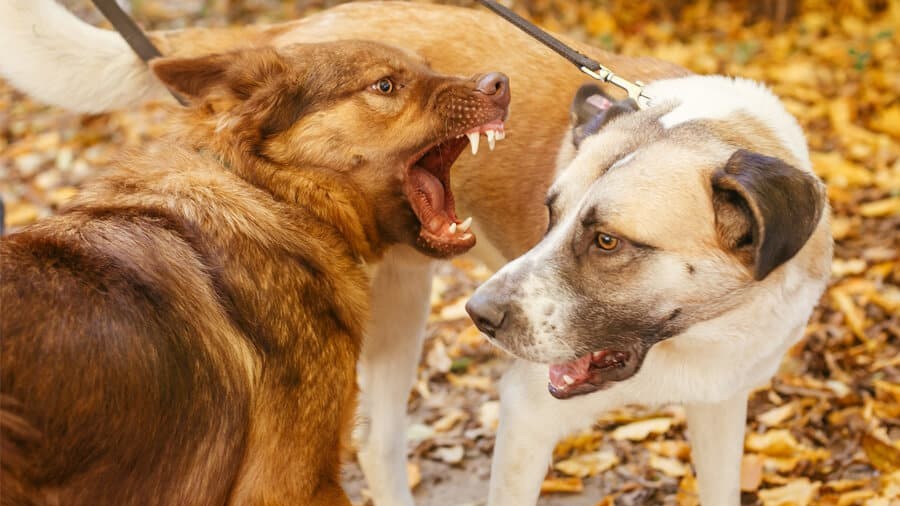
[150,48,286,100]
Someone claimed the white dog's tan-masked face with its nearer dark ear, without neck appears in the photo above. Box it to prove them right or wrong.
[468,100,824,398]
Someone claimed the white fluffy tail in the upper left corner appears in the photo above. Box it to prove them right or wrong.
[0,0,167,113]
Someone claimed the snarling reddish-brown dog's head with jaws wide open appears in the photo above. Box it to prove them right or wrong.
[152,41,510,257]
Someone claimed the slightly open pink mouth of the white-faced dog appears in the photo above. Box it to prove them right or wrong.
[548,350,644,399]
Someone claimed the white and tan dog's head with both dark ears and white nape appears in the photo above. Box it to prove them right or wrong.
[467,77,830,398]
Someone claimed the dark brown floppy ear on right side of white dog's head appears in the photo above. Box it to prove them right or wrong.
[712,149,825,281]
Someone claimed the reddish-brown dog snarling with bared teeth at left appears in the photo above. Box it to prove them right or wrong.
[0,41,509,505]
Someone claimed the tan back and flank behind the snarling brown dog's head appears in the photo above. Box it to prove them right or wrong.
[144,2,688,262]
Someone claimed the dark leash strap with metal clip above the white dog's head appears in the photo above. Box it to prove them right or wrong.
[479,0,650,109]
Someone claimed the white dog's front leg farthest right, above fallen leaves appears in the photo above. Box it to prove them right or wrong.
[685,391,748,506]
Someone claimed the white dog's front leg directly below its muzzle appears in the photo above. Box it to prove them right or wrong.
[488,361,591,506]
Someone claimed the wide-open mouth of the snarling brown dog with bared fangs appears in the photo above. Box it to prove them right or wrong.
[404,120,504,256]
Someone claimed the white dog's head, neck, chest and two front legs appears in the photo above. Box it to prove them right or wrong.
[467,76,831,506]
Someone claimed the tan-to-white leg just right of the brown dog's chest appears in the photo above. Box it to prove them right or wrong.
[359,248,432,506]
